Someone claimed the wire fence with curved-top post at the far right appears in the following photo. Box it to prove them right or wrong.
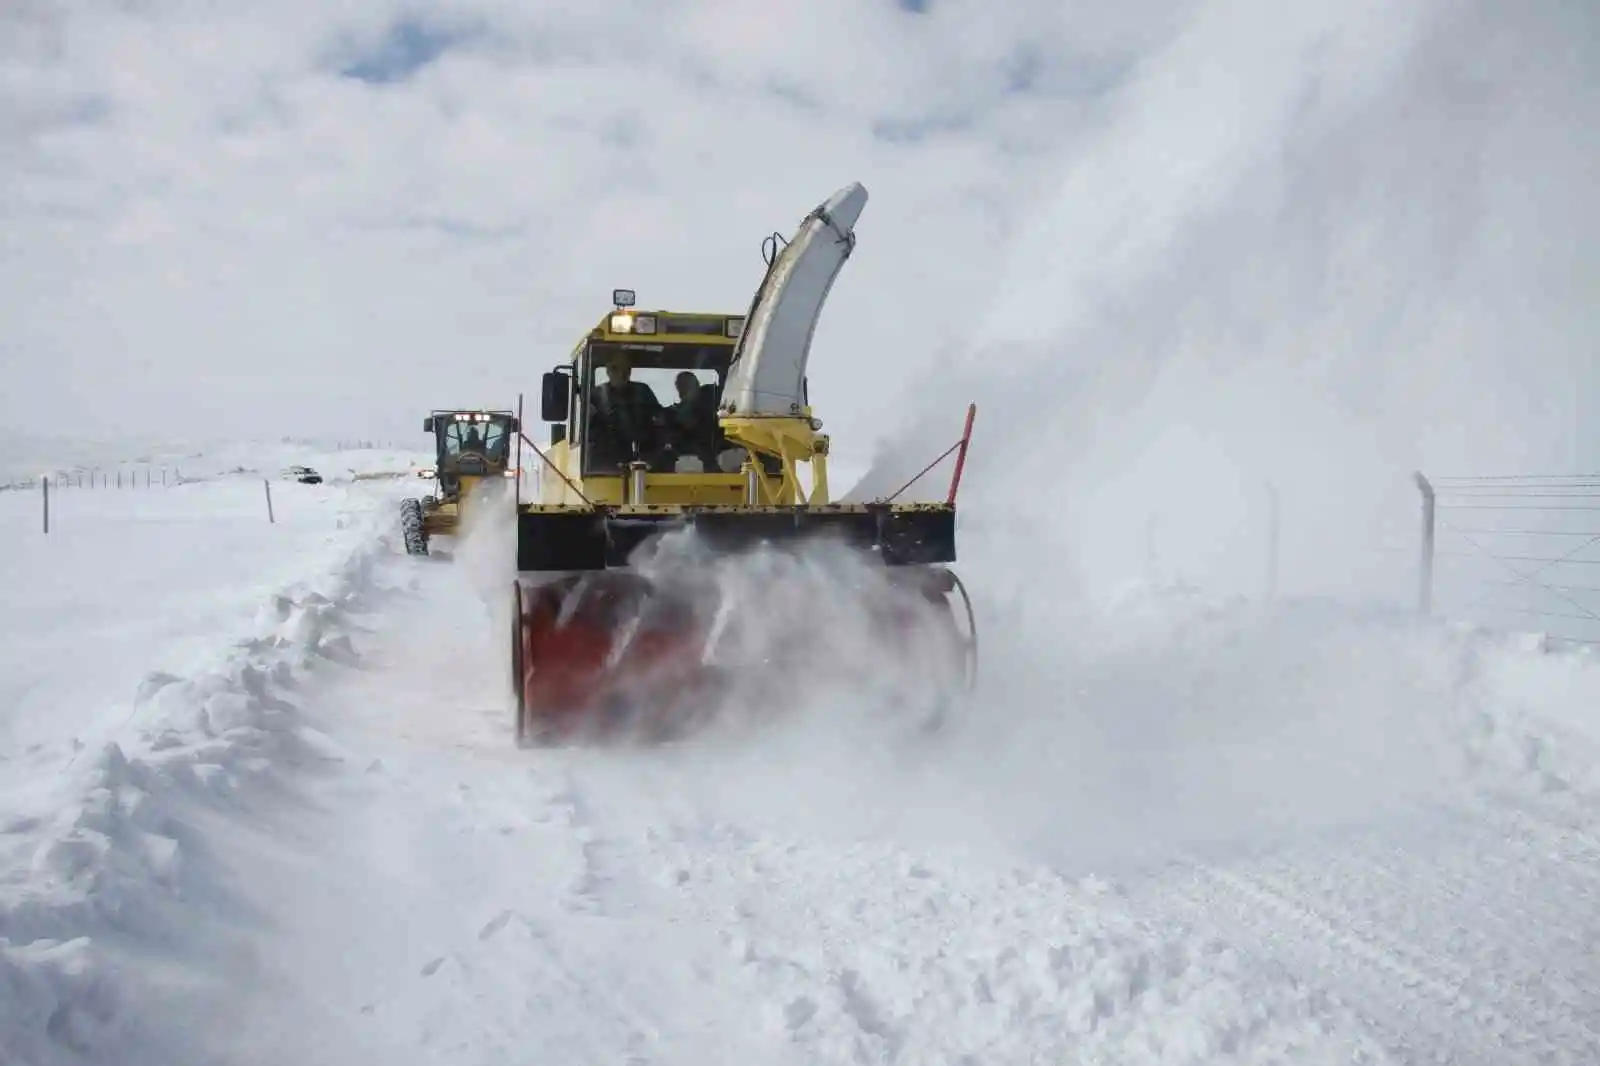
[1416,474,1600,647]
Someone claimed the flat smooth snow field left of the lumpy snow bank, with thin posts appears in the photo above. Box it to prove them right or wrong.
[0,464,394,765]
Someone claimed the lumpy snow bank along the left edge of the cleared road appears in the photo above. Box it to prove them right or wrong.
[0,480,412,1066]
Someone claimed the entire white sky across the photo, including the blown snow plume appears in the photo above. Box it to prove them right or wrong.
[0,0,1600,598]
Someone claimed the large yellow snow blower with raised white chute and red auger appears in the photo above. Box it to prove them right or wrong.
[510,184,976,744]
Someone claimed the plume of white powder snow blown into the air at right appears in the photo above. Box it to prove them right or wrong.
[838,0,1600,602]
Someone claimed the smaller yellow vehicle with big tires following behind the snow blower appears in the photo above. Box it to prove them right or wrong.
[400,410,522,555]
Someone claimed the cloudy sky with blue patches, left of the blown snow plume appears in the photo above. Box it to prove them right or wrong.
[0,0,1186,443]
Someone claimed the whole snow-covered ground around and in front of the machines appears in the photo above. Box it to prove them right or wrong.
[0,441,1600,1066]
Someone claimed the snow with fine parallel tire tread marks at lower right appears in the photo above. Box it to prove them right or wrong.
[1136,797,1600,1066]
